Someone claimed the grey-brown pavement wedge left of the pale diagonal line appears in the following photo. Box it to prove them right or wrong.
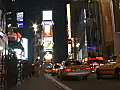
[10,66,64,90]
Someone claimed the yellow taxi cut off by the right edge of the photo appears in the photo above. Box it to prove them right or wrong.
[96,56,120,79]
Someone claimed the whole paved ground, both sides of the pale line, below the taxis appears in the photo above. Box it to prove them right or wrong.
[11,66,120,90]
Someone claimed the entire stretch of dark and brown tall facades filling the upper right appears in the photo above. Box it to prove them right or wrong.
[67,0,120,60]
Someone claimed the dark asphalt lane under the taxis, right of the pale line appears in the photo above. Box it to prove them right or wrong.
[48,74,120,90]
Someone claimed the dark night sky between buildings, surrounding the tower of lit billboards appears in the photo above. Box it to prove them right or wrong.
[16,0,67,62]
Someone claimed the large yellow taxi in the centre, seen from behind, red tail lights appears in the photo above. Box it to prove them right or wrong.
[57,60,92,79]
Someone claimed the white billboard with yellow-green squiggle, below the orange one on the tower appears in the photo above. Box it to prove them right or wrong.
[44,37,53,51]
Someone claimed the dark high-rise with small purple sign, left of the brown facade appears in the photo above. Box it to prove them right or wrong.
[67,0,102,60]
